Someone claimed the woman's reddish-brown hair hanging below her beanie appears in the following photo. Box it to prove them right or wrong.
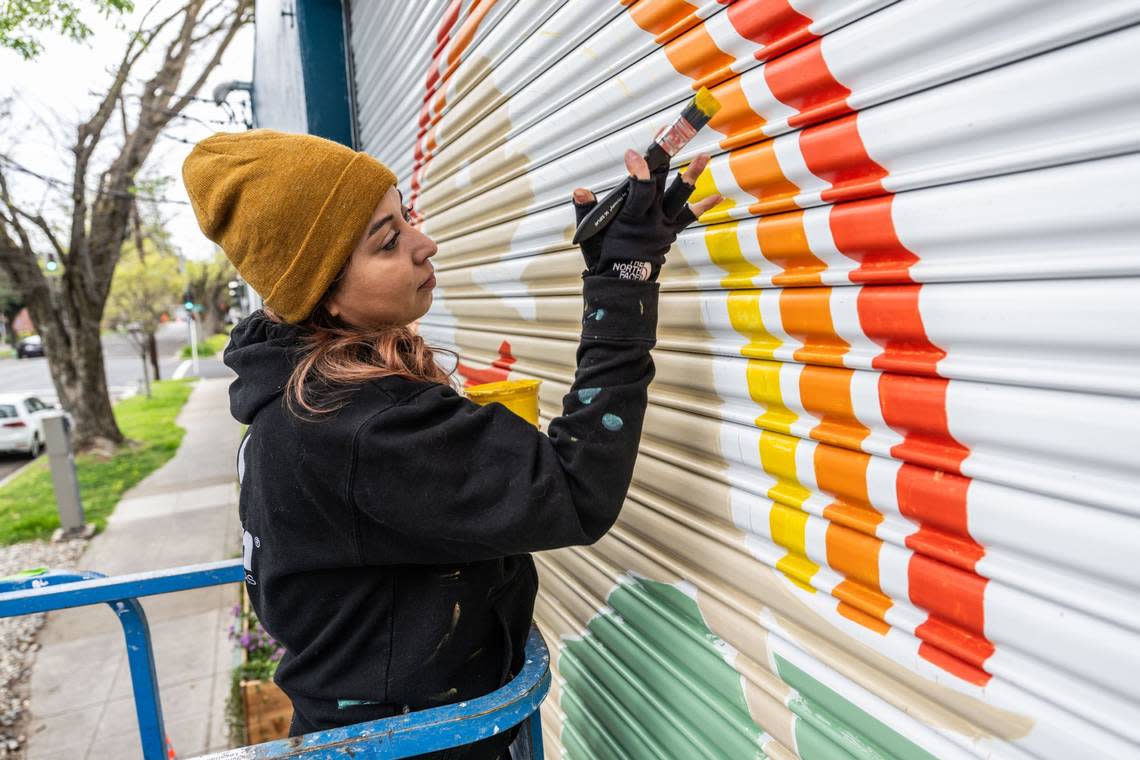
[264,293,455,415]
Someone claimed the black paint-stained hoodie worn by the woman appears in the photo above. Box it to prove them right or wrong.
[225,276,658,757]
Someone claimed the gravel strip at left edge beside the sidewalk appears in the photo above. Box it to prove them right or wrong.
[0,539,87,760]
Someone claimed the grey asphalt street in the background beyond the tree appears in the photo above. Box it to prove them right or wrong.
[0,322,231,479]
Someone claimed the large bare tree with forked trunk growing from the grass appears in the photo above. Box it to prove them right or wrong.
[0,0,253,450]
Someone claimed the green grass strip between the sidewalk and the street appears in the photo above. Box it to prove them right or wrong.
[0,381,193,546]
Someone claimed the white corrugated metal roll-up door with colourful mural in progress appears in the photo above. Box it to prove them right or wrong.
[350,0,1140,760]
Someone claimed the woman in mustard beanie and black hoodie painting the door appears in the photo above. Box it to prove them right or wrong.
[184,130,718,758]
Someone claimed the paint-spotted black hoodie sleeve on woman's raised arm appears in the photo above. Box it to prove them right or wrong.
[351,276,658,564]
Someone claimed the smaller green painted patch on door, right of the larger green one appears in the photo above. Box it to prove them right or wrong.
[775,654,936,760]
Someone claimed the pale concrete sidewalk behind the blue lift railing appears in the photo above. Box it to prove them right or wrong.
[26,378,242,760]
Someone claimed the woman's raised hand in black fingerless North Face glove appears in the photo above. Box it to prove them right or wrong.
[573,149,722,280]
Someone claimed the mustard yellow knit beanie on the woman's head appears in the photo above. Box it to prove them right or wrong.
[182,129,396,322]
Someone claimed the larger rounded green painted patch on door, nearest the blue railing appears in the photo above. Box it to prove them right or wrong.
[559,579,765,760]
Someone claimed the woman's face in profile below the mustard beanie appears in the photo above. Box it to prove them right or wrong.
[327,187,437,329]
